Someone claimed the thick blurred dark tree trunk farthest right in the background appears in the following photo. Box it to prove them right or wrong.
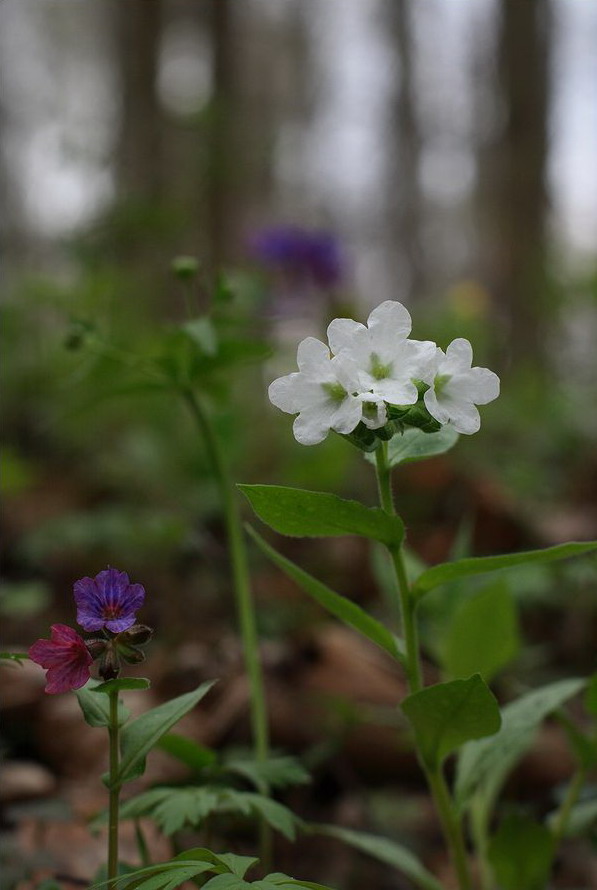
[492,0,551,365]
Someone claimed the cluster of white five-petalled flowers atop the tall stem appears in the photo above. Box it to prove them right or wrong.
[269,300,500,445]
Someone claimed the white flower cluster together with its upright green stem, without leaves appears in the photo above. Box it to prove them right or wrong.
[269,300,499,890]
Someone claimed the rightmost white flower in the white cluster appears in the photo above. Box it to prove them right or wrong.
[423,337,500,435]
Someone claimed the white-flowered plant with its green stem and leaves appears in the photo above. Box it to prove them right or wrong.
[240,301,597,890]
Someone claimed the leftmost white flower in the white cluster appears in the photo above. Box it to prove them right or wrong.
[268,337,386,445]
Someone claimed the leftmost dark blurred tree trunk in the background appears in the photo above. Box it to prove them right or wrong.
[114,0,163,200]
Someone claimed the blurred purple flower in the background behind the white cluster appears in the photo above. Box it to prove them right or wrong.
[250,226,343,288]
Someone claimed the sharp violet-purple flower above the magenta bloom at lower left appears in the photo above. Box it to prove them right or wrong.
[75,568,145,633]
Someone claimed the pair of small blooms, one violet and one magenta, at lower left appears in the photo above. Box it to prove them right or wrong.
[29,568,145,694]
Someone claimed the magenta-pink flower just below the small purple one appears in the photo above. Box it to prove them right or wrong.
[29,624,93,695]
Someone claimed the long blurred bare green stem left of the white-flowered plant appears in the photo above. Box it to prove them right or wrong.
[182,389,269,763]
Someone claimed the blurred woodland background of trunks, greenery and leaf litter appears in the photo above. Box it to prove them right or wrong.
[0,0,597,888]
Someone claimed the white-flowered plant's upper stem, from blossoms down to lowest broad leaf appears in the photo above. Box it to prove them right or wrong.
[375,442,423,692]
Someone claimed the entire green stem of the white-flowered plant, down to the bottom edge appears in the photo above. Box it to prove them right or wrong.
[375,442,472,890]
